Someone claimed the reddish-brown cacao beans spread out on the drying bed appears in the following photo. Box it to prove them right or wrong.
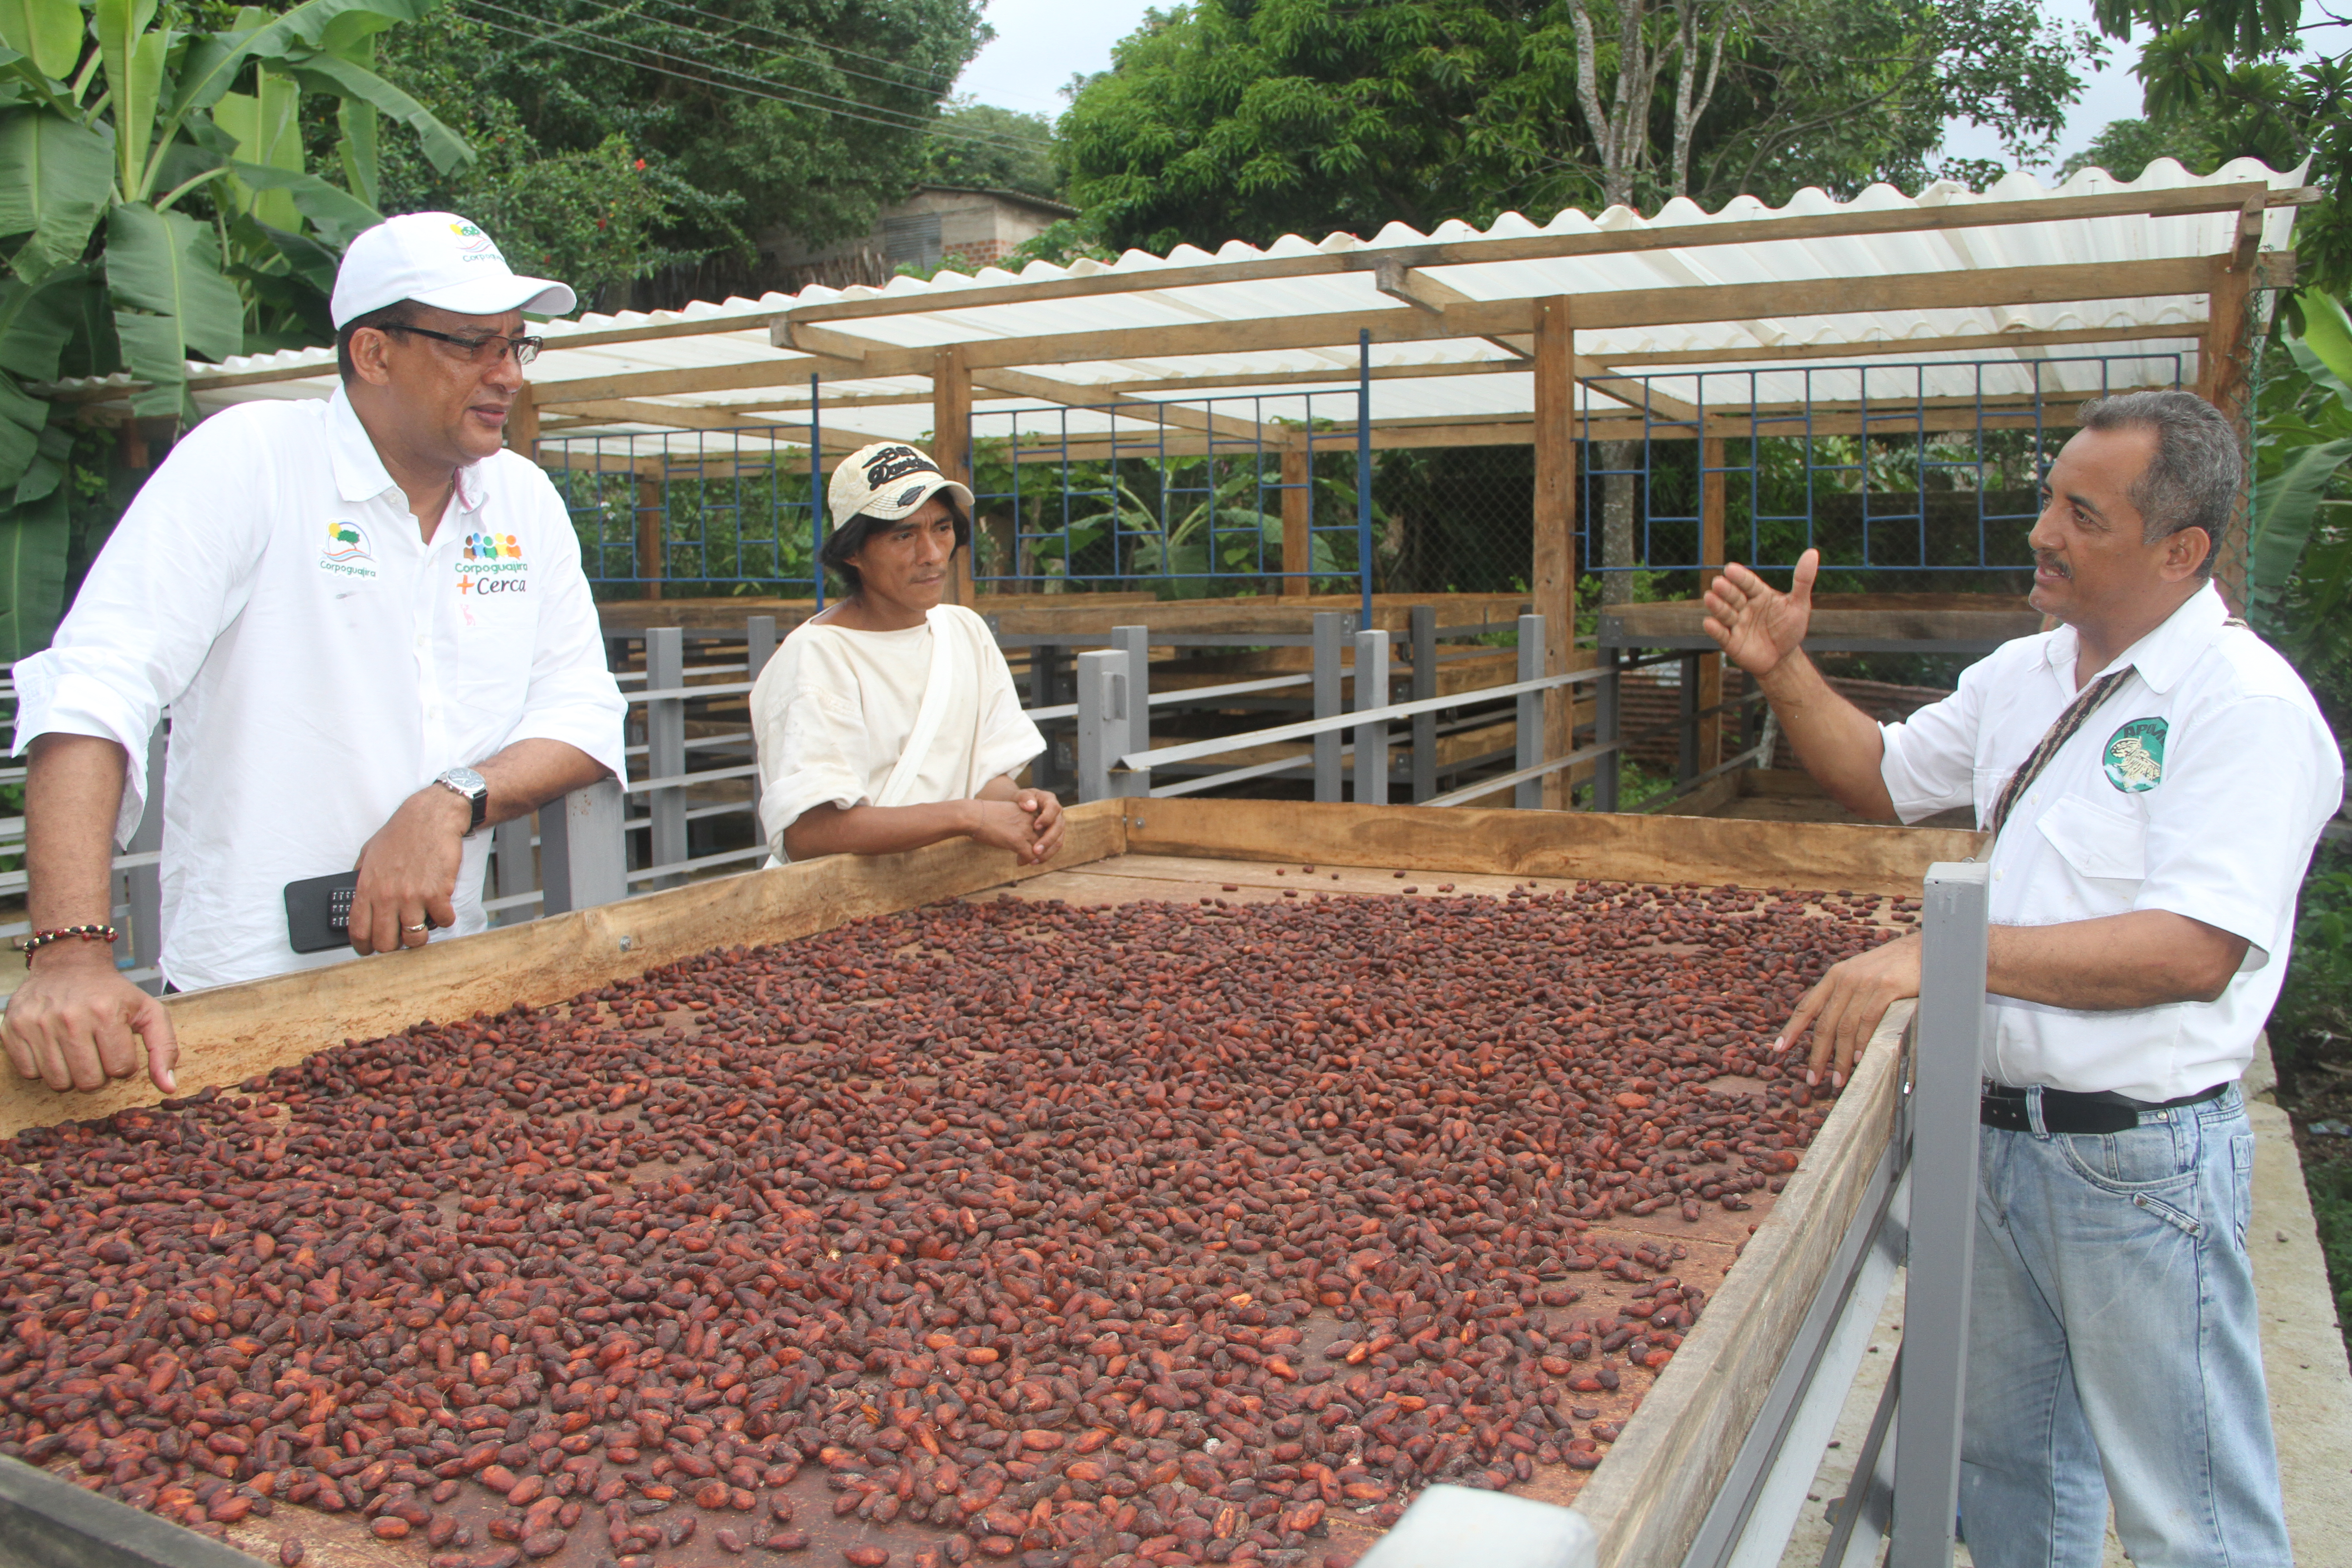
[0,867,1917,1568]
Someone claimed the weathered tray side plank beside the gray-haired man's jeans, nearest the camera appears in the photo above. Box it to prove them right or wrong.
[1576,1001,1915,1568]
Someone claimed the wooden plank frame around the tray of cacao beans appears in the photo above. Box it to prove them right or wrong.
[0,799,1980,1568]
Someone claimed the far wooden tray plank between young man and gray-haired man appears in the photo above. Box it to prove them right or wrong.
[1127,797,1983,896]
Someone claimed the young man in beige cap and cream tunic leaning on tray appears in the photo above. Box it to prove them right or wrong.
[750,442,1061,865]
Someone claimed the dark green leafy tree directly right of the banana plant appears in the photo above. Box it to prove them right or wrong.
[423,0,988,287]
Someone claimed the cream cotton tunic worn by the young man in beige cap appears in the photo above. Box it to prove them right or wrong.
[750,604,1044,860]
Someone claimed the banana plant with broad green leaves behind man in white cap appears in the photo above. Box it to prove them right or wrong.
[0,0,473,661]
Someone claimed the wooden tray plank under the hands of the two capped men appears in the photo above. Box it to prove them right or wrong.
[0,802,1129,1138]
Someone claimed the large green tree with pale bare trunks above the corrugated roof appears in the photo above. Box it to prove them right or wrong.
[1061,0,2091,249]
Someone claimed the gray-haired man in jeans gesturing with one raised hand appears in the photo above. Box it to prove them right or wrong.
[1708,392,2342,1568]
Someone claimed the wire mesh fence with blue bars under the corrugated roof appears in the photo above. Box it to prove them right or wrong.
[541,353,2192,599]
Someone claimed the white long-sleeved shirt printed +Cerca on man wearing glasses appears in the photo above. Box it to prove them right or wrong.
[16,388,623,990]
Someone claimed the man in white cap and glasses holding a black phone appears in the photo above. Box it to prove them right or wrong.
[5,211,623,1093]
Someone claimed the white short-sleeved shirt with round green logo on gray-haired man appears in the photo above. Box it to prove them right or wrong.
[1879,583,2342,1100]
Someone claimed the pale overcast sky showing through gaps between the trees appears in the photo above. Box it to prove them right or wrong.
[957,0,2220,200]
